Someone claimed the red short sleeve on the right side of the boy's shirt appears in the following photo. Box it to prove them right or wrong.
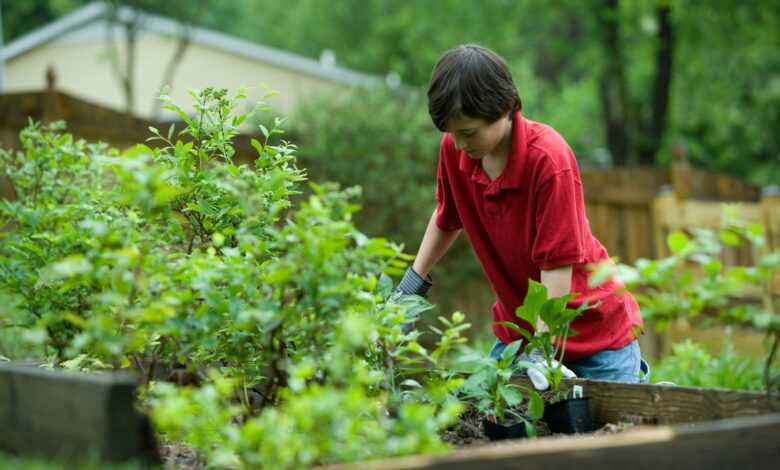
[531,169,588,269]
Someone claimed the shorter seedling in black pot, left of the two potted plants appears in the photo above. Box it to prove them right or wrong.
[460,340,544,441]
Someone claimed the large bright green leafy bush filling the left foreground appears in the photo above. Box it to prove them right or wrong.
[0,88,476,468]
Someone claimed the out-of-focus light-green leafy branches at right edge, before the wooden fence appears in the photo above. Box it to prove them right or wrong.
[592,206,780,400]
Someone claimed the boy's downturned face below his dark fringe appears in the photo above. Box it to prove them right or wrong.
[445,113,512,160]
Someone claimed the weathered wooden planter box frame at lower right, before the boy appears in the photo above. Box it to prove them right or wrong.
[348,378,780,470]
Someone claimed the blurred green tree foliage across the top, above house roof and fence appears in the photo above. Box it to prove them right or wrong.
[3,0,780,184]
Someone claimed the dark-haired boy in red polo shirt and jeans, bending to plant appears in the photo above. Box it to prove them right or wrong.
[399,44,648,390]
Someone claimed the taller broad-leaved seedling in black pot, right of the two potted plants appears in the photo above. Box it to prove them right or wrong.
[502,280,593,434]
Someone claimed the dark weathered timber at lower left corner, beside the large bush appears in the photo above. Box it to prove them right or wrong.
[0,363,160,463]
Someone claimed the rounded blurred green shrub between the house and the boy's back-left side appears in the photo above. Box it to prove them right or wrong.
[292,86,490,319]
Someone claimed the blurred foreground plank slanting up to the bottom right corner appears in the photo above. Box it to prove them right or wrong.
[358,414,780,470]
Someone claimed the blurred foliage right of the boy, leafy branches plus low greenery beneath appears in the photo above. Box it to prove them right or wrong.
[590,211,780,398]
